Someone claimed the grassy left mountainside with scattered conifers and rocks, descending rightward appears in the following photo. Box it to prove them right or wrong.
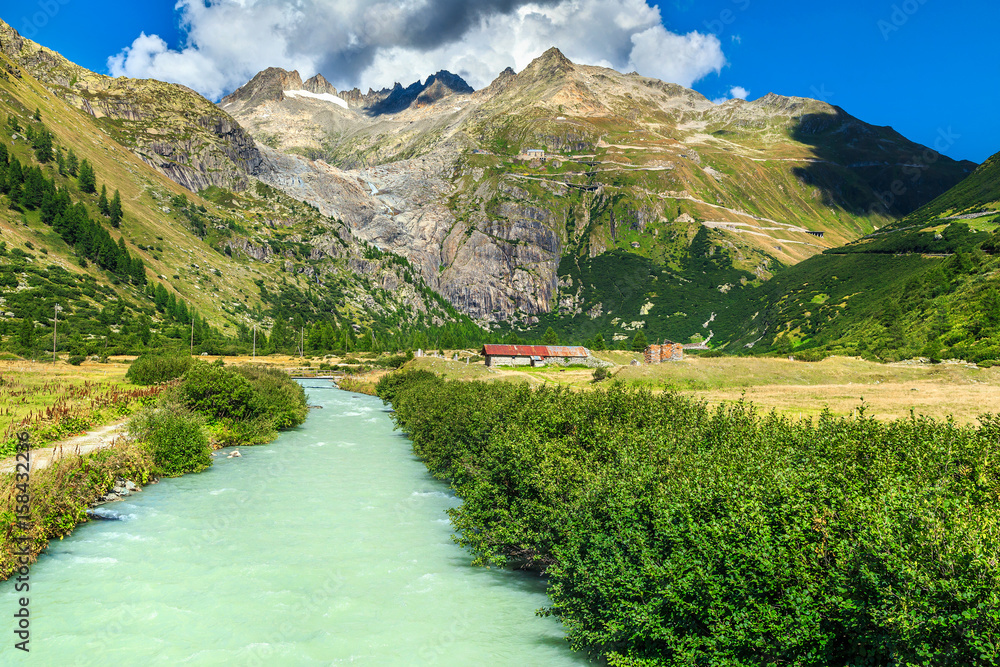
[0,23,480,354]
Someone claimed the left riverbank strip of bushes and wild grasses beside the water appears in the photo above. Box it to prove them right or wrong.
[0,362,308,580]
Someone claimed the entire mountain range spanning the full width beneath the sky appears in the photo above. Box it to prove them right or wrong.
[0,14,996,360]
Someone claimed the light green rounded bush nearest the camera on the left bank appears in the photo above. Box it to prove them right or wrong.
[128,402,212,477]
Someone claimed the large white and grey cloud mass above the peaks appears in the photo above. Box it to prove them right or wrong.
[108,0,726,99]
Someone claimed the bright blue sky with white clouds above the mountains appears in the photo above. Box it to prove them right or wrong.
[0,0,1000,162]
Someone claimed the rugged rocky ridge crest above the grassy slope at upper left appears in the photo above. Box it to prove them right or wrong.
[0,21,267,191]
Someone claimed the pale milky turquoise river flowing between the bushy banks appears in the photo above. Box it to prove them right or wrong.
[0,388,586,666]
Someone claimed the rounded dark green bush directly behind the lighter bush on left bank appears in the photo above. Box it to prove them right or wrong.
[180,361,266,421]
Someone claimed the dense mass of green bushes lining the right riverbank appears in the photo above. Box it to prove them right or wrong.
[378,373,1000,667]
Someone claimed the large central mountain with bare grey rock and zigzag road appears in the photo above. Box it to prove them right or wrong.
[222,49,974,338]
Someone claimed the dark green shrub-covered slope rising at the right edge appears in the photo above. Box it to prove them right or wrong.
[738,149,1000,362]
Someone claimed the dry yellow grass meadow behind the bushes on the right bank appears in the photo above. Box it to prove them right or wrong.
[412,352,1000,424]
